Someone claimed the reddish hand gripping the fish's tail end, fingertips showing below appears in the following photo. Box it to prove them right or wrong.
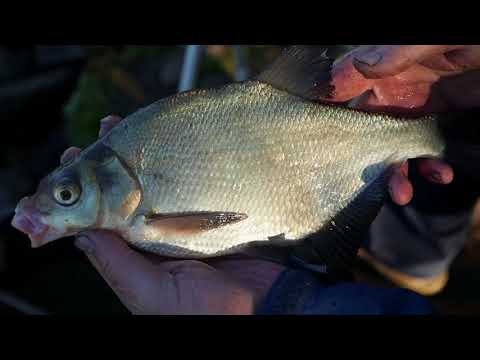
[320,45,480,205]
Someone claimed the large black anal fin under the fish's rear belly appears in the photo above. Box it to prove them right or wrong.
[291,169,390,282]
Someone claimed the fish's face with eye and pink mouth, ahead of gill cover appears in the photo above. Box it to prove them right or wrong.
[12,161,100,247]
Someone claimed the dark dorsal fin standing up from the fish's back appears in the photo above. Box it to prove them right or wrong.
[256,45,354,100]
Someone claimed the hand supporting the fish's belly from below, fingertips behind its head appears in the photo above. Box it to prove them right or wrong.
[61,116,285,315]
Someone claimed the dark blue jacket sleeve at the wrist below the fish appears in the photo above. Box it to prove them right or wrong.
[257,269,434,315]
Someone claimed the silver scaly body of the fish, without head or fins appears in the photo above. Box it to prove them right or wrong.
[103,81,442,256]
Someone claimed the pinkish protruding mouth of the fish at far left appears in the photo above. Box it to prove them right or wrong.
[11,200,61,248]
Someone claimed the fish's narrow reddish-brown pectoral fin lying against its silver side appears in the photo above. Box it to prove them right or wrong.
[145,211,247,234]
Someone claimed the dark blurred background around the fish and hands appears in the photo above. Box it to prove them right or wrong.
[0,45,480,315]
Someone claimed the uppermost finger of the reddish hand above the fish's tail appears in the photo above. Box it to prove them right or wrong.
[353,45,463,79]
